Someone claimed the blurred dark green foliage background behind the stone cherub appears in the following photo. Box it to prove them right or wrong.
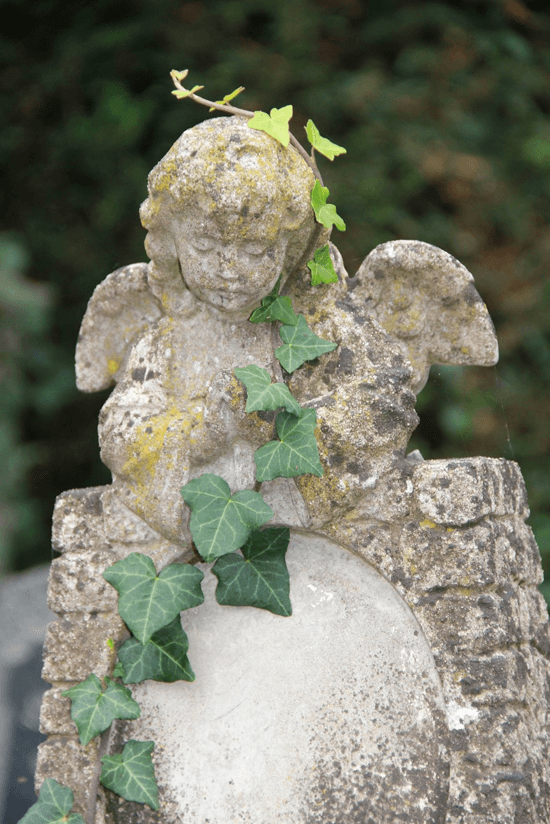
[0,0,550,600]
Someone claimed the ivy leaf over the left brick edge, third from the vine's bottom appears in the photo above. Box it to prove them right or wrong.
[62,673,141,746]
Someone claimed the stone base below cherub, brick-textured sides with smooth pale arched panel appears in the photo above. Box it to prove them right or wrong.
[37,458,550,824]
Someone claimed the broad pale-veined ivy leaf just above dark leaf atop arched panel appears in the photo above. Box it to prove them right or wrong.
[181,474,274,561]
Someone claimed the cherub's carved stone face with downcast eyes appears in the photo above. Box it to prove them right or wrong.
[175,212,292,319]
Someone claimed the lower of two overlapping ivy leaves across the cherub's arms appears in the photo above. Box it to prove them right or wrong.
[254,409,323,481]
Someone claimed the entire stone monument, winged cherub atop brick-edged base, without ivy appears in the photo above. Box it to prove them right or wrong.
[36,108,550,824]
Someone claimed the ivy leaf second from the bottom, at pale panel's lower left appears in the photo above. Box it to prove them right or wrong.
[99,739,159,810]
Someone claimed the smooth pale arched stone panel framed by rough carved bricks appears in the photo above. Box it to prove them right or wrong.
[118,534,448,824]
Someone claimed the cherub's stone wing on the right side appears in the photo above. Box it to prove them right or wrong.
[352,240,498,394]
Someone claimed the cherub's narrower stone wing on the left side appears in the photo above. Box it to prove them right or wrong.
[76,263,163,392]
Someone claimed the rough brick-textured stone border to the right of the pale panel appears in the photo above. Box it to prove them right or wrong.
[333,458,550,824]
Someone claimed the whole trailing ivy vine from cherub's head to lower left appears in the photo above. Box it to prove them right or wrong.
[19,70,346,824]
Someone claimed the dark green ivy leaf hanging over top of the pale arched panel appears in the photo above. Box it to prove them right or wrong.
[212,527,292,615]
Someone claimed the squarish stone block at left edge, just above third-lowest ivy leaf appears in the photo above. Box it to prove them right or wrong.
[42,612,126,684]
